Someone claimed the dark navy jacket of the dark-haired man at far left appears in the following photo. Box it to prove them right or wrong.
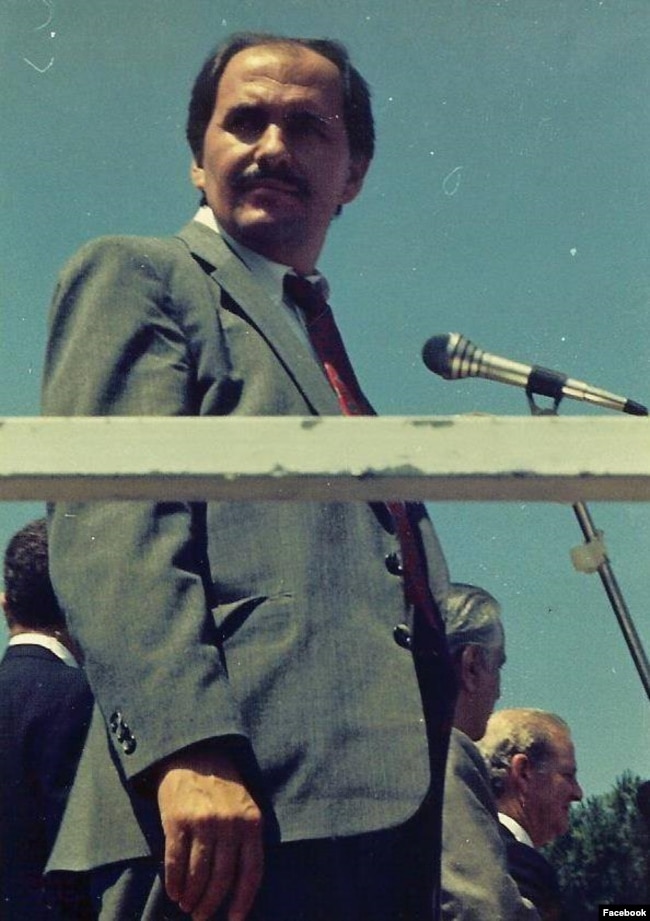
[0,644,92,921]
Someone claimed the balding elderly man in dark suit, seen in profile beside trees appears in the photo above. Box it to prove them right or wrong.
[480,707,582,921]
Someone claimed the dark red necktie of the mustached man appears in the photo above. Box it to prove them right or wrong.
[284,274,441,634]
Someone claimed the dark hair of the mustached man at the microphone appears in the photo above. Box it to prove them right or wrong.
[186,32,375,165]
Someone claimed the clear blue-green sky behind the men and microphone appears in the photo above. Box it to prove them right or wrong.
[0,0,650,794]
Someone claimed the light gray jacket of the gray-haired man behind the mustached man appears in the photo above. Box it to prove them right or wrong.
[442,729,539,921]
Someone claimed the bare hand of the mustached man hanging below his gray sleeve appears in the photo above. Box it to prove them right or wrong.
[158,750,264,921]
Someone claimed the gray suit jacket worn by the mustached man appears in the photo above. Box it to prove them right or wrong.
[43,223,447,869]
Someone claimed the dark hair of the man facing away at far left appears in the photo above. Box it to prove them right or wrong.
[4,518,65,629]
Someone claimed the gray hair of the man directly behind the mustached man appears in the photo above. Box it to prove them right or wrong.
[441,582,503,656]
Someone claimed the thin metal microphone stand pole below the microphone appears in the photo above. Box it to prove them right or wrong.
[526,387,650,699]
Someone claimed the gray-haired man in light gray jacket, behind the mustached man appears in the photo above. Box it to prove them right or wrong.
[442,583,539,921]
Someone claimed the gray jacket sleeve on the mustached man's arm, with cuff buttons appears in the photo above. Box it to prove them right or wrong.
[43,238,248,777]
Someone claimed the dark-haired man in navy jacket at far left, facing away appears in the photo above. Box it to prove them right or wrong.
[0,518,92,921]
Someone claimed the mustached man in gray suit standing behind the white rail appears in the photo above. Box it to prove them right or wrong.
[44,35,453,921]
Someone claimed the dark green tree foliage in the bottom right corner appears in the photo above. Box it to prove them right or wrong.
[545,772,650,921]
